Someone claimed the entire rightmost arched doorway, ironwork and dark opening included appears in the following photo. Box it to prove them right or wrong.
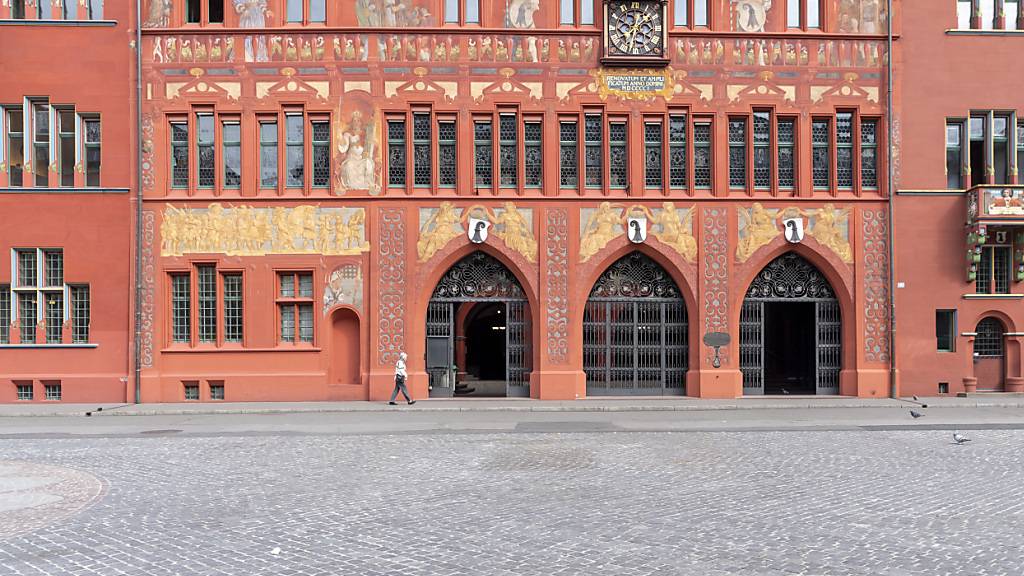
[739,252,843,396]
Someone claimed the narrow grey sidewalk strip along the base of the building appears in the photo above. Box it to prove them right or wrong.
[0,394,1024,417]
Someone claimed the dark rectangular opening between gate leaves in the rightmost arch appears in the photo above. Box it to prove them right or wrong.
[765,302,815,395]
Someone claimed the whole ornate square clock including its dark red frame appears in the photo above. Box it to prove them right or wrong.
[601,0,669,66]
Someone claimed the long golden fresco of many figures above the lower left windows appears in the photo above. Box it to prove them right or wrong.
[160,202,370,256]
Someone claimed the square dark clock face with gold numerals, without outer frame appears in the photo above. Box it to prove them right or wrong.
[607,0,665,56]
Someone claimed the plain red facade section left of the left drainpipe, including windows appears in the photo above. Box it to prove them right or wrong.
[0,0,134,402]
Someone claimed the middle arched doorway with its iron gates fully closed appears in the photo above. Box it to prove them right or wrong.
[583,252,689,396]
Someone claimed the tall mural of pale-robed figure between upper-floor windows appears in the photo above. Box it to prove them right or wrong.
[333,92,381,194]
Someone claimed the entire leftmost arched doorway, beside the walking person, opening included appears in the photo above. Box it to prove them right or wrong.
[427,252,531,398]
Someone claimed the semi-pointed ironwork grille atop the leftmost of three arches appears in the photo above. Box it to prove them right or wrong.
[431,252,526,300]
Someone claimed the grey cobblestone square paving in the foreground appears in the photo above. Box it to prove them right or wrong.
[0,429,1024,576]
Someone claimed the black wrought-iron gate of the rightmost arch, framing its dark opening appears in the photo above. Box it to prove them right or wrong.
[739,252,843,396]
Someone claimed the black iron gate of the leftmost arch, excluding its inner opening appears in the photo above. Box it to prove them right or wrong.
[426,252,532,398]
